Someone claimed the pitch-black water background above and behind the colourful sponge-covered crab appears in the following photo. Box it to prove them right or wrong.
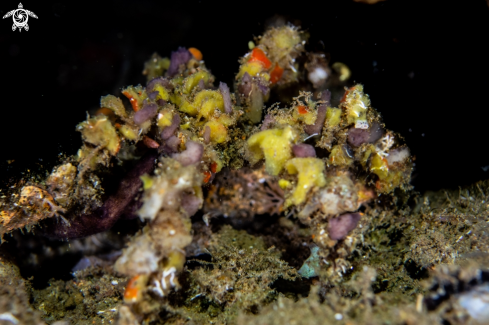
[0,0,489,191]
